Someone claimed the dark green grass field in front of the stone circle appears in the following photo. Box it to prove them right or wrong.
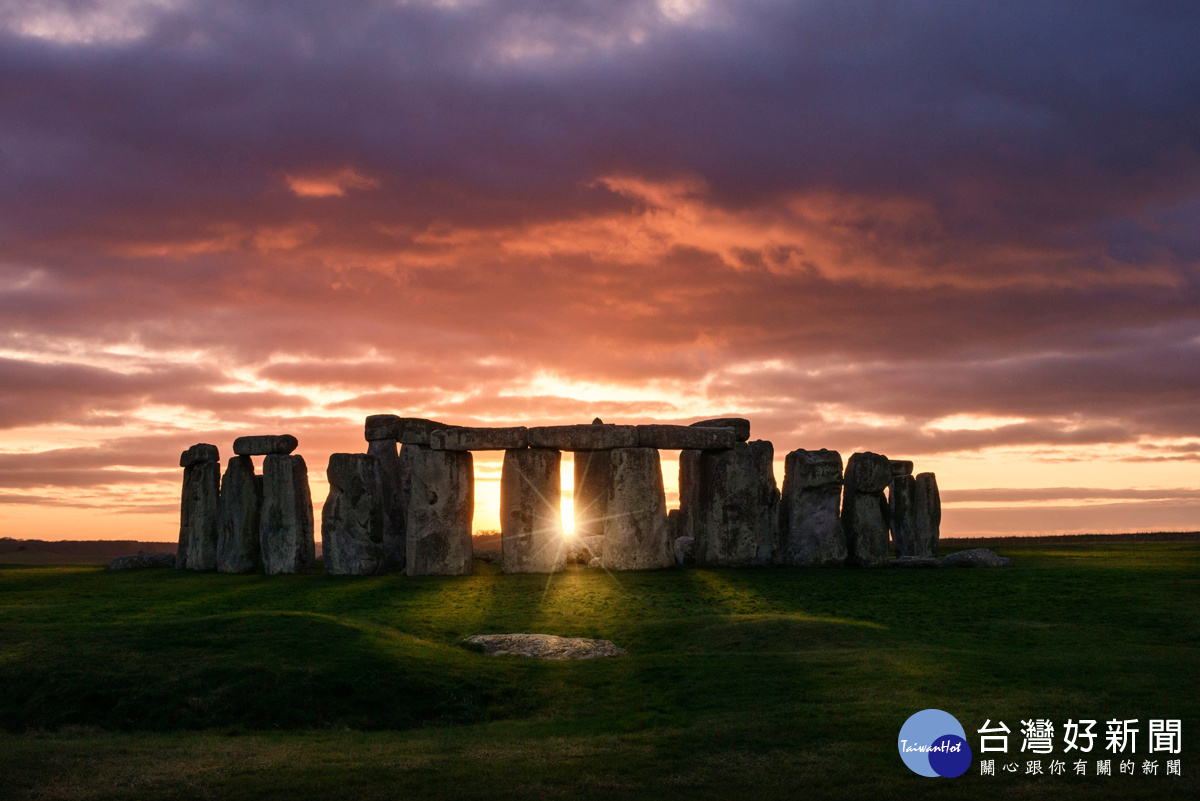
[0,543,1200,801]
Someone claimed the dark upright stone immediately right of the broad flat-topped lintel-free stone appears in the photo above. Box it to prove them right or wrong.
[841,451,892,567]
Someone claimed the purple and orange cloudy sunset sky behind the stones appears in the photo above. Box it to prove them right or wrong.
[0,0,1200,540]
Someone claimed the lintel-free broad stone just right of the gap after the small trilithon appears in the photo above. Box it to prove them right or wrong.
[320,453,385,576]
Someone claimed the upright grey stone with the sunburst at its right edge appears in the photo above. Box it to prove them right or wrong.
[500,448,566,573]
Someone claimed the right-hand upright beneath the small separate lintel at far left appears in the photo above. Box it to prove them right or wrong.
[258,453,317,574]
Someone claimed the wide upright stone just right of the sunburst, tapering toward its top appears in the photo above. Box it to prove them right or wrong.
[600,448,674,570]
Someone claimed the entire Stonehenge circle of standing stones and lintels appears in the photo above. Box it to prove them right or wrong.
[175,414,941,577]
